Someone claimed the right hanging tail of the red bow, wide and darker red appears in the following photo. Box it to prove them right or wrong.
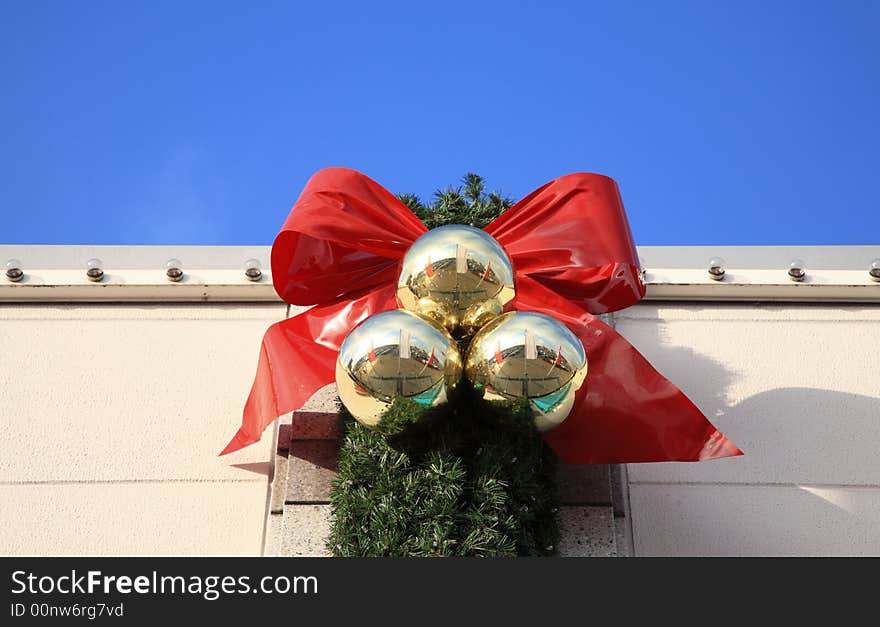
[545,318,743,464]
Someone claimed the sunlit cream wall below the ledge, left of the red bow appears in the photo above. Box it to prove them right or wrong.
[0,304,286,555]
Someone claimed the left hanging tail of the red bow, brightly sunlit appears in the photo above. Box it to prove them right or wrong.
[220,286,397,455]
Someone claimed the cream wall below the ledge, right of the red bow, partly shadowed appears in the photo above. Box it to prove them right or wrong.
[615,302,880,555]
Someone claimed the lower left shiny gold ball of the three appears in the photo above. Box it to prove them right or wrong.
[336,309,462,426]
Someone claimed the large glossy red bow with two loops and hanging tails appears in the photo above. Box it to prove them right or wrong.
[221,168,742,464]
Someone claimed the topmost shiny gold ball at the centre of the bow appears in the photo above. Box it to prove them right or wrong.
[397,224,514,337]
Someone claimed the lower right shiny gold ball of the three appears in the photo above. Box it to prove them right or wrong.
[464,311,587,431]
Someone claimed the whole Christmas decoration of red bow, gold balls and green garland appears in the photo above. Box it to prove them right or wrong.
[223,169,741,556]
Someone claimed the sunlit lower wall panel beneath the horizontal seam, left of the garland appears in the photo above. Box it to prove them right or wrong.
[0,480,266,556]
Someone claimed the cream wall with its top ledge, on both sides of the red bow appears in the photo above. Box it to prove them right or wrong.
[0,246,880,555]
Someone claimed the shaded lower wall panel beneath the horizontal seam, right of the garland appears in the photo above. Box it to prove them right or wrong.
[630,484,880,557]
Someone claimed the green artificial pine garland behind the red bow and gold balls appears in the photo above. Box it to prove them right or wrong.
[327,174,559,557]
